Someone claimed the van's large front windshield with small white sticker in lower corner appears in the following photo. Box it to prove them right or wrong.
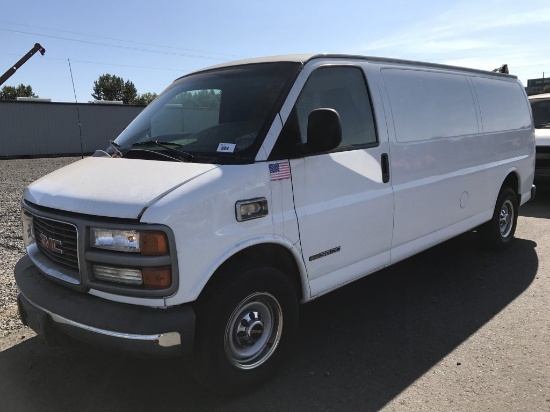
[111,63,301,164]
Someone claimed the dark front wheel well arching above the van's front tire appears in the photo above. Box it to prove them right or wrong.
[197,243,303,306]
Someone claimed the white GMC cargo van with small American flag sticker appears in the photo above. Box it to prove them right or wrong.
[15,55,535,391]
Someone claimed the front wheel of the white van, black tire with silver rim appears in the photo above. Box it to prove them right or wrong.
[187,265,299,395]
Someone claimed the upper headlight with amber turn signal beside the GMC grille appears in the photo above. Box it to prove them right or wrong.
[90,227,168,256]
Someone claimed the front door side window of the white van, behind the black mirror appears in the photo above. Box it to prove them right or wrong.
[271,66,377,159]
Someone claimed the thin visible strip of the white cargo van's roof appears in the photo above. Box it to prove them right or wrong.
[185,54,517,79]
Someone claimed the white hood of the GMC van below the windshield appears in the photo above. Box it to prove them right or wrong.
[23,157,217,219]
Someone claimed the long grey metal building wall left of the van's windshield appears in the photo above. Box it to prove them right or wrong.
[0,101,143,158]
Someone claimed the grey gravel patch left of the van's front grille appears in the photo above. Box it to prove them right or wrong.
[0,157,80,338]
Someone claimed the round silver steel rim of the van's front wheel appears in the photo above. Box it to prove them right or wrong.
[224,292,283,369]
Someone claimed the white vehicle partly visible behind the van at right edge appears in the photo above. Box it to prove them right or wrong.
[529,93,550,179]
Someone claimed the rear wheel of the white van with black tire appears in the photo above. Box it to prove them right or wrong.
[480,187,519,250]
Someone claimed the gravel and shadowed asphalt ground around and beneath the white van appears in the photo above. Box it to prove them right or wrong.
[0,159,550,412]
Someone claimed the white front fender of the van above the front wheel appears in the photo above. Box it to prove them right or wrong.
[141,162,306,305]
